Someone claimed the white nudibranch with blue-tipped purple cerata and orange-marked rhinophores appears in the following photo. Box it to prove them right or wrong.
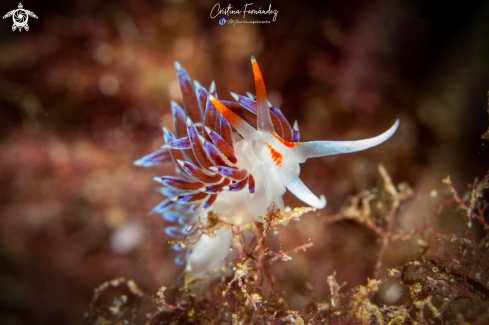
[134,56,399,279]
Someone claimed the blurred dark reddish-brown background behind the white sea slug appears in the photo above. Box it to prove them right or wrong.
[0,0,489,325]
